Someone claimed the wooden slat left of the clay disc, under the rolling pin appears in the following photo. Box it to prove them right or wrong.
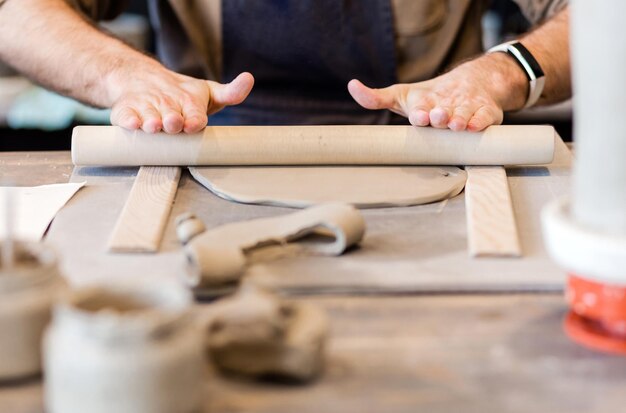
[109,166,181,252]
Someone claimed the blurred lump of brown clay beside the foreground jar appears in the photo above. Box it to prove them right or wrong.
[207,286,328,382]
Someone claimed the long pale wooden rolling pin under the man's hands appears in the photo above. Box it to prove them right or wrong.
[72,125,555,166]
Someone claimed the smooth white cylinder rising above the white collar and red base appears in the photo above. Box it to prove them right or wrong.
[571,0,626,235]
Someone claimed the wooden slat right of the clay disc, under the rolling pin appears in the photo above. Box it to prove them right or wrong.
[465,166,522,257]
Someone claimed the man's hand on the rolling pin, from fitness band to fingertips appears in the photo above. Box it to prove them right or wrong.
[348,53,528,131]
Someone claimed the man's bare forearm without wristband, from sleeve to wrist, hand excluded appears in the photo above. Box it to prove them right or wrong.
[0,0,162,107]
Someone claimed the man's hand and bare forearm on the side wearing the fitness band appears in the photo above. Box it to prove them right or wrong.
[348,8,571,131]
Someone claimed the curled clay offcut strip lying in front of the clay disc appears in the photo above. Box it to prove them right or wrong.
[182,204,365,287]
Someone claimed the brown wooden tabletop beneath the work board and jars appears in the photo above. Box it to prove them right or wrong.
[0,152,626,413]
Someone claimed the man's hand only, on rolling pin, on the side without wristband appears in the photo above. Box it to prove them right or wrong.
[110,66,254,133]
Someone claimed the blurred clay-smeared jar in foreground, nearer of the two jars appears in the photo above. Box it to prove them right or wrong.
[44,284,206,413]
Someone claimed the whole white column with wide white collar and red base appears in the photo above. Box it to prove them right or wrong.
[543,0,626,355]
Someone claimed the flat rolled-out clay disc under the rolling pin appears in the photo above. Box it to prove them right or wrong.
[189,166,466,208]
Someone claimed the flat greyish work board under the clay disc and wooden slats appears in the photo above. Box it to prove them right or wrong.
[47,138,572,294]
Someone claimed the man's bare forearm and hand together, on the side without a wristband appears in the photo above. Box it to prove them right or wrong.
[0,0,254,133]
